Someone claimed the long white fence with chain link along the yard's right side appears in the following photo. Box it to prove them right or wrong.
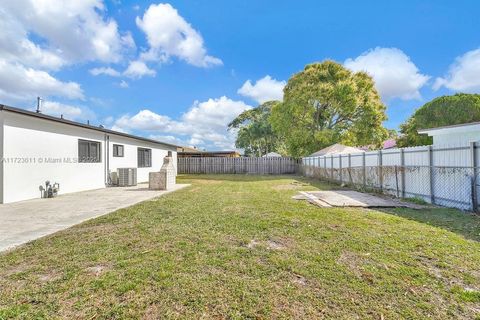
[302,143,480,211]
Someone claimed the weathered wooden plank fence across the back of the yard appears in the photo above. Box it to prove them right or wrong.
[177,157,299,174]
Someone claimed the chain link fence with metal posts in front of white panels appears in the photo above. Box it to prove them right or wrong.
[301,162,480,211]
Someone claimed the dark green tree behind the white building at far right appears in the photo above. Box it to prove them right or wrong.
[397,93,480,147]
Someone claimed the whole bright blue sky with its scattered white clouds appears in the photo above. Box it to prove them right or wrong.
[0,0,480,149]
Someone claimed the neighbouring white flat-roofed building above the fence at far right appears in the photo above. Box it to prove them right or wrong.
[418,122,480,145]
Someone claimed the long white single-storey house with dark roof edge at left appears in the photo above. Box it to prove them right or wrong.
[0,105,177,203]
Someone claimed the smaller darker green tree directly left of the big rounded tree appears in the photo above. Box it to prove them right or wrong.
[228,101,280,157]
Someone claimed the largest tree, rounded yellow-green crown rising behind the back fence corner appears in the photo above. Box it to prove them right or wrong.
[271,61,388,157]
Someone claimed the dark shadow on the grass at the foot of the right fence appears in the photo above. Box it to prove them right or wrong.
[377,207,480,242]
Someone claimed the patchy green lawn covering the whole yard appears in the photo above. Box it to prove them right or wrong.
[0,175,480,319]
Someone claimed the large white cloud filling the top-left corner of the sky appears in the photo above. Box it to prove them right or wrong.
[0,0,134,69]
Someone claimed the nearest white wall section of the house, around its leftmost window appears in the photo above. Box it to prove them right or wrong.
[2,112,105,203]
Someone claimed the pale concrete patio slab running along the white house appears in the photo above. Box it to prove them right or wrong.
[0,184,188,252]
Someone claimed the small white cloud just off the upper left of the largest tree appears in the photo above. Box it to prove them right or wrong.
[237,75,286,103]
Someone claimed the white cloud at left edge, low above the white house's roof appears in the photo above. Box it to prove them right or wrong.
[0,59,84,102]
